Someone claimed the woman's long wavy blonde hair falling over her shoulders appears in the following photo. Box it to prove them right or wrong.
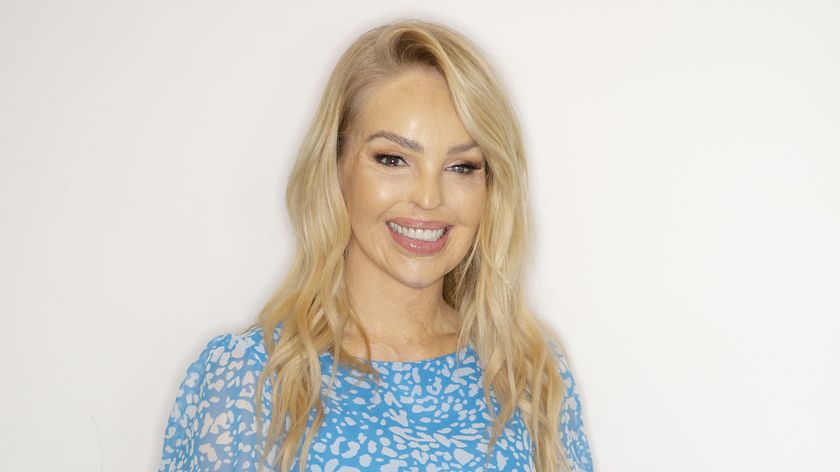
[255,20,568,472]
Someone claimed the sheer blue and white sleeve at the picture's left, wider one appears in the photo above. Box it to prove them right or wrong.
[159,334,270,472]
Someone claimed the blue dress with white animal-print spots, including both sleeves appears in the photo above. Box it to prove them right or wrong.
[159,329,592,472]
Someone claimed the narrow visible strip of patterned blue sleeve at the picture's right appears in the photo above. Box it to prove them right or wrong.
[552,345,593,472]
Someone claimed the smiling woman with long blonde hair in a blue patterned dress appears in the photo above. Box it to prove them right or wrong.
[156,20,592,471]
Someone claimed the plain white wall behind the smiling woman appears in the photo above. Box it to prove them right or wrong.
[0,0,840,472]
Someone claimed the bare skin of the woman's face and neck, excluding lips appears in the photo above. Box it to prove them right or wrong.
[339,68,487,361]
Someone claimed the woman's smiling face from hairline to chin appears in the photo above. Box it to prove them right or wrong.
[340,65,487,288]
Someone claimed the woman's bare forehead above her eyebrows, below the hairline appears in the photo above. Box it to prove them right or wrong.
[351,68,469,141]
